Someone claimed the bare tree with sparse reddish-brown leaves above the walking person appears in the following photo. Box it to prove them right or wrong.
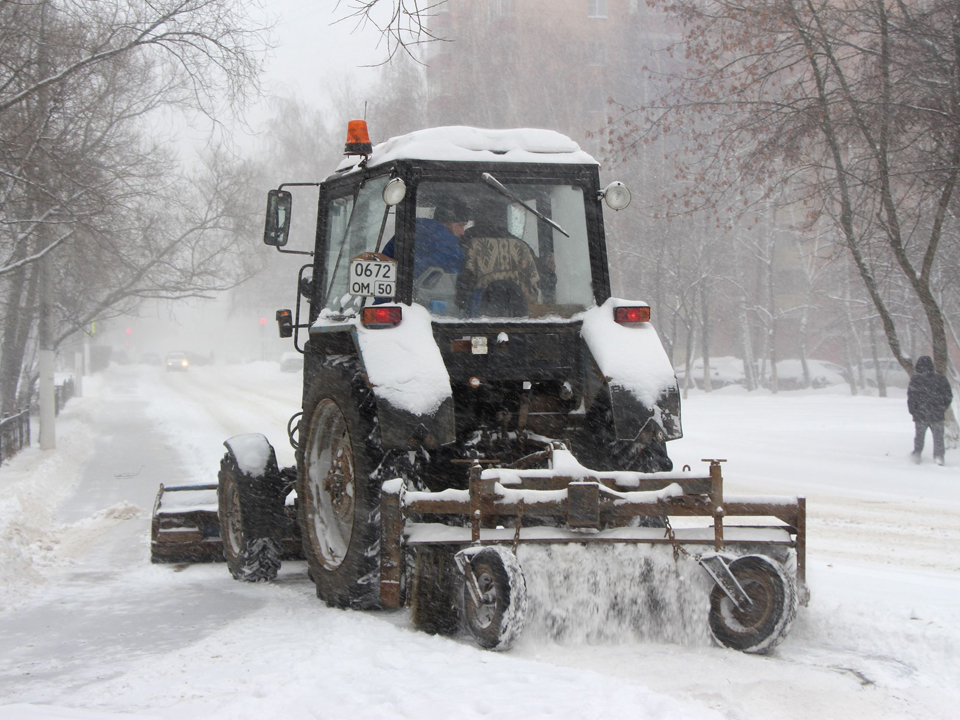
[617,0,960,400]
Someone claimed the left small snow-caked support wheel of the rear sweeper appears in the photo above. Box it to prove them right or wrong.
[463,546,527,650]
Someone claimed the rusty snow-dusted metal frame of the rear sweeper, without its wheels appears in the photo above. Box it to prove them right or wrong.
[380,452,809,608]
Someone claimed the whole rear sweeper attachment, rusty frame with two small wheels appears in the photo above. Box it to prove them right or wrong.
[380,443,808,653]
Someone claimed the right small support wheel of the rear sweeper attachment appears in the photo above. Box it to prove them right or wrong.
[710,555,797,653]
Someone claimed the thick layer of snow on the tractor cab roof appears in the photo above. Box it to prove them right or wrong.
[337,126,600,171]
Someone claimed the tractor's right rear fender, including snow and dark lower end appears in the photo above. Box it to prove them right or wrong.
[580,298,683,440]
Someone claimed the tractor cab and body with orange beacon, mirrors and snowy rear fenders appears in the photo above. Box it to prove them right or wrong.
[264,123,680,478]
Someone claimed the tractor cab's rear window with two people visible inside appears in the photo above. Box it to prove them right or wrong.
[413,178,594,318]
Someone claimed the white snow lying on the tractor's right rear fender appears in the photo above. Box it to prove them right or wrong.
[580,298,676,407]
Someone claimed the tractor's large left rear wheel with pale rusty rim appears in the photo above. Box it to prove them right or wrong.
[297,365,383,609]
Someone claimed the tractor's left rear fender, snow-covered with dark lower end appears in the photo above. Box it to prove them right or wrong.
[311,305,456,449]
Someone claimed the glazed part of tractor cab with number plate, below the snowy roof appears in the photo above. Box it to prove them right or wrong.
[313,161,610,322]
